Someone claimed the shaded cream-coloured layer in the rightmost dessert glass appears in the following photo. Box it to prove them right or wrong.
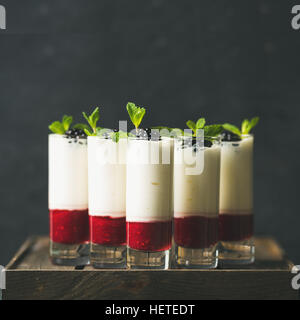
[220,136,254,214]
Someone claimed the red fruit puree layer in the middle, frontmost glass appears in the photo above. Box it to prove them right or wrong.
[127,220,172,251]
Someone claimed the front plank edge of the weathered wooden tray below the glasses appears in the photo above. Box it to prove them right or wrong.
[3,270,298,300]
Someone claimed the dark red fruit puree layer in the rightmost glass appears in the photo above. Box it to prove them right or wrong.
[219,214,253,241]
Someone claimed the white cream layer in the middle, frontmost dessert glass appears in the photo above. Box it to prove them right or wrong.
[126,139,173,222]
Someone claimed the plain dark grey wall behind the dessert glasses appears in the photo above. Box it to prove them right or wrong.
[0,0,300,264]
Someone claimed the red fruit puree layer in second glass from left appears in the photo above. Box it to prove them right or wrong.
[90,216,126,247]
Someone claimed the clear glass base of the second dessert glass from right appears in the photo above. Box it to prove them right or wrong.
[174,245,218,269]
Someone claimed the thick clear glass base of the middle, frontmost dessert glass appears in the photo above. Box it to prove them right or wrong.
[127,248,171,270]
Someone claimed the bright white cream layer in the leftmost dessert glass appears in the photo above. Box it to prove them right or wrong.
[49,134,88,210]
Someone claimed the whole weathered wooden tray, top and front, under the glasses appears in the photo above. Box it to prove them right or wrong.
[3,237,298,300]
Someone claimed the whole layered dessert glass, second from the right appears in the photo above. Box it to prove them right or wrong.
[174,137,221,268]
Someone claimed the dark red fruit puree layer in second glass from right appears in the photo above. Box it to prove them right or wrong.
[174,216,218,249]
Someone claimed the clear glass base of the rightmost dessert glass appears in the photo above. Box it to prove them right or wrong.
[219,238,255,266]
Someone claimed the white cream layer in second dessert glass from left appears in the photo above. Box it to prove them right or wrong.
[88,137,127,218]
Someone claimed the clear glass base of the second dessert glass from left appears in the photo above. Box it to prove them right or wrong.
[90,243,126,269]
